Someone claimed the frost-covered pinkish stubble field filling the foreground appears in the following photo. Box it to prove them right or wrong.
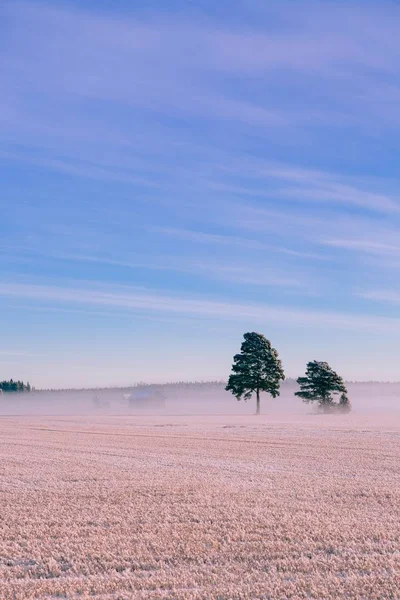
[0,415,400,600]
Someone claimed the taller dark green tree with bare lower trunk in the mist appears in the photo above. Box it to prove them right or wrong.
[225,332,285,414]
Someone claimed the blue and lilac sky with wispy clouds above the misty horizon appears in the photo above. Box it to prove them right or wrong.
[0,0,400,388]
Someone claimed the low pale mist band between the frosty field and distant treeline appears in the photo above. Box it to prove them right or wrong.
[0,380,400,418]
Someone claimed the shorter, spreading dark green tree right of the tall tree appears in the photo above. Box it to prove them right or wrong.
[295,360,351,412]
